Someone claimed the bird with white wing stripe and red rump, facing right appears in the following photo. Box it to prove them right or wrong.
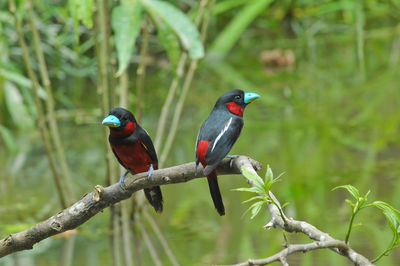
[195,89,260,216]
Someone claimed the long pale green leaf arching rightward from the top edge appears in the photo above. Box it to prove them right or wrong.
[141,0,204,59]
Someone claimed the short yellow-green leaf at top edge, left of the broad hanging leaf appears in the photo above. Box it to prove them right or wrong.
[68,0,94,40]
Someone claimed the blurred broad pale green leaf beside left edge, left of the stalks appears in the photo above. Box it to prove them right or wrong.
[4,81,34,129]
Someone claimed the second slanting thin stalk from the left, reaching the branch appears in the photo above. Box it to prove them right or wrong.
[26,0,75,204]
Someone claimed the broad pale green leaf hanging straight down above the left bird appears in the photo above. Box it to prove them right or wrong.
[111,0,144,76]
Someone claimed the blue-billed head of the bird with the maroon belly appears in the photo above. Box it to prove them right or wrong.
[102,107,136,131]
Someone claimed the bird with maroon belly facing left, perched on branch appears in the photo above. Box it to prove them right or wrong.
[102,107,163,212]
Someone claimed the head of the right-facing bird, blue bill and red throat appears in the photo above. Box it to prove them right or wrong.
[215,90,260,116]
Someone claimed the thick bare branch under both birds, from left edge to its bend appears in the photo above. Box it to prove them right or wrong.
[0,156,261,258]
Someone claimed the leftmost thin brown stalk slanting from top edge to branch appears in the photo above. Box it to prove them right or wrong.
[9,0,67,208]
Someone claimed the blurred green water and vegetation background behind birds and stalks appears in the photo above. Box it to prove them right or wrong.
[0,0,400,265]
